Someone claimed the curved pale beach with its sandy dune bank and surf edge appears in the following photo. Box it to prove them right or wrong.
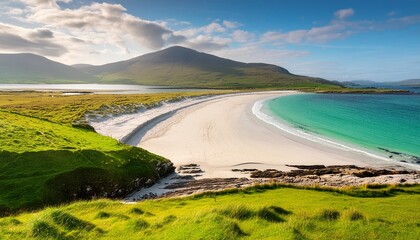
[89,91,419,177]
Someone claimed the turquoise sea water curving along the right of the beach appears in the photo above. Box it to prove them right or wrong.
[264,94,420,164]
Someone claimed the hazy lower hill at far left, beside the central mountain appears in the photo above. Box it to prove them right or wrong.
[0,53,97,83]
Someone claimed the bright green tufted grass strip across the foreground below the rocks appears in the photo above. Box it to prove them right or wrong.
[0,186,420,239]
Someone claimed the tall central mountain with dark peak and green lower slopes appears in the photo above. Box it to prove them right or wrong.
[74,46,335,88]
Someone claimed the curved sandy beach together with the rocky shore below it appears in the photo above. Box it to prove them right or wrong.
[88,91,420,200]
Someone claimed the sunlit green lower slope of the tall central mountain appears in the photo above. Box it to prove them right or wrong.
[101,64,341,89]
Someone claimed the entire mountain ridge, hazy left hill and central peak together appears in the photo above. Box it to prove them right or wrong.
[0,46,337,89]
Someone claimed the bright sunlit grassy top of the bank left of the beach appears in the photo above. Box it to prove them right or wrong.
[0,110,127,153]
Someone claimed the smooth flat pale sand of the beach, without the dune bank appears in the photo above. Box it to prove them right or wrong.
[138,92,395,177]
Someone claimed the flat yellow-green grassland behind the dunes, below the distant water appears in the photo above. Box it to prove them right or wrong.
[0,91,226,123]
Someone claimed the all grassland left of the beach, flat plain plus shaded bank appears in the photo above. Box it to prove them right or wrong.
[0,93,223,211]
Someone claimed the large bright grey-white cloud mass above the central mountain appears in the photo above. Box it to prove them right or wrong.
[0,0,235,61]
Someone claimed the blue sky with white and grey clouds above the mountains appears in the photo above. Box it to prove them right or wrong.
[0,0,420,81]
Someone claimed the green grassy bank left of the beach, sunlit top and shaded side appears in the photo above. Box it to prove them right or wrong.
[0,112,167,211]
